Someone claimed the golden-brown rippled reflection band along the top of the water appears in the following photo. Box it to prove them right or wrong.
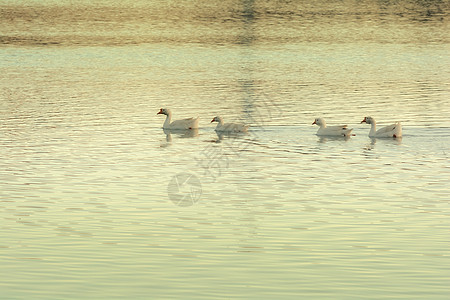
[0,0,449,45]
